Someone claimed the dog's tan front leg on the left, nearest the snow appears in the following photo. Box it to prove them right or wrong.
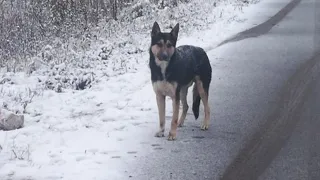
[155,94,166,137]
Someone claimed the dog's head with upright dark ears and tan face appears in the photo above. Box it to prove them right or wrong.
[151,22,179,61]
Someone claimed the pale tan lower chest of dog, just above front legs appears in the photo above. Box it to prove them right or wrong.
[152,81,177,97]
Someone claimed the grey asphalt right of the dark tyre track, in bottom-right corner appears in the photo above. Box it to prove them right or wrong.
[259,57,320,180]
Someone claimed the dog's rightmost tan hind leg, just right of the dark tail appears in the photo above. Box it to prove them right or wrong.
[195,76,210,130]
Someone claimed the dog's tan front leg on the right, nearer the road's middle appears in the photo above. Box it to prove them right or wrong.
[168,95,180,141]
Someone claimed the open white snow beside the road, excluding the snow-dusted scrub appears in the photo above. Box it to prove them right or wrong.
[0,0,268,180]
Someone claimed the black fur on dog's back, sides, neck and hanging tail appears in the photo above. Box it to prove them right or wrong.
[149,45,212,119]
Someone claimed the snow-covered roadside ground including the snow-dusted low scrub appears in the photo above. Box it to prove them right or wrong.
[0,0,282,180]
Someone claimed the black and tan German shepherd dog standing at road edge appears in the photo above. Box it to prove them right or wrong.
[149,22,212,140]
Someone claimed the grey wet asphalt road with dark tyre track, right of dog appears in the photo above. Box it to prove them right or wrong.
[128,0,320,180]
